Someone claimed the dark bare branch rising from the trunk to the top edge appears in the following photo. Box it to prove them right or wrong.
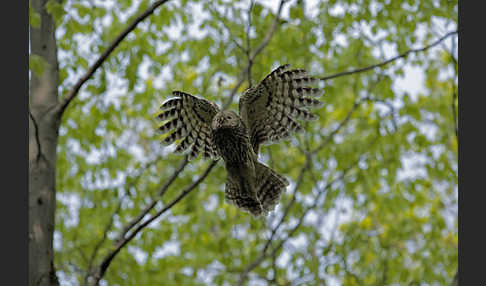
[57,0,169,115]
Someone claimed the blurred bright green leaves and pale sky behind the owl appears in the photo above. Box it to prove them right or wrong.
[30,0,458,285]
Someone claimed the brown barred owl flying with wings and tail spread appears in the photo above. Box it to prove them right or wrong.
[158,65,321,217]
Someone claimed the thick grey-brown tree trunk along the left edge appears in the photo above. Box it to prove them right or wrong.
[29,0,60,285]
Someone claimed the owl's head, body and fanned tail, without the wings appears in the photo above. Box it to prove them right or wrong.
[212,111,288,217]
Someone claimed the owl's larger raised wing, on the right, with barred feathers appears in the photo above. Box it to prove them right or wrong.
[239,65,322,154]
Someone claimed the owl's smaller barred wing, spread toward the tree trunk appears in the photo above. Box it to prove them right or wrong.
[157,91,219,160]
